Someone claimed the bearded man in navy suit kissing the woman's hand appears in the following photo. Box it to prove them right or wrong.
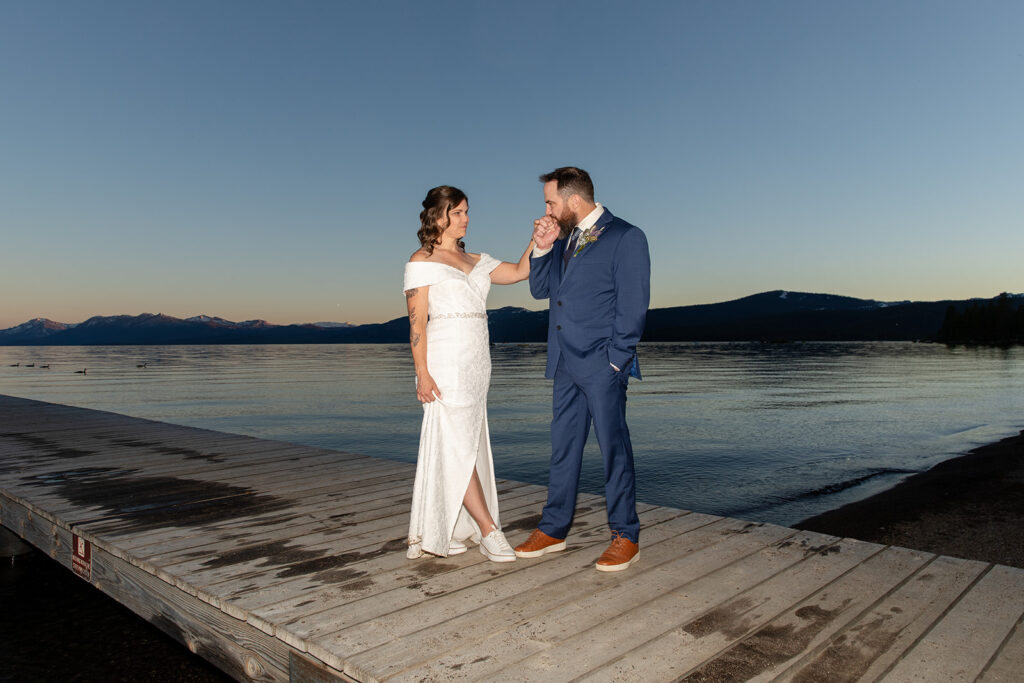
[515,166,650,571]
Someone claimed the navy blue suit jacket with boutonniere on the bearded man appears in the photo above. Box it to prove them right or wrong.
[529,209,650,379]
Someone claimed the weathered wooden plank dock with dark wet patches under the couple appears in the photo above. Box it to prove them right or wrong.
[0,395,1024,682]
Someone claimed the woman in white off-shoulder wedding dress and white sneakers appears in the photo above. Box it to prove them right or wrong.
[404,185,534,562]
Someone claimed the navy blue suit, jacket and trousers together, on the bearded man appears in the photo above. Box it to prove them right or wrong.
[529,209,650,543]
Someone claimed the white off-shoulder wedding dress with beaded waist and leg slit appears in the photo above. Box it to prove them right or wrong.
[404,254,501,558]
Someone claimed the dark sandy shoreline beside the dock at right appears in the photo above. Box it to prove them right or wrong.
[794,431,1024,567]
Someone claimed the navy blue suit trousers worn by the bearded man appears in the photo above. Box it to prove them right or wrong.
[538,359,640,543]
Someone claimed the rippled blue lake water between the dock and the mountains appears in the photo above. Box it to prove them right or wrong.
[0,343,1024,524]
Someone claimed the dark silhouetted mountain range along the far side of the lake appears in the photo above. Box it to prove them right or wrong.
[0,290,1024,346]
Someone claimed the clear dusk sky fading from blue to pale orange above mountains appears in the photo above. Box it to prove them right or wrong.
[0,0,1024,329]
